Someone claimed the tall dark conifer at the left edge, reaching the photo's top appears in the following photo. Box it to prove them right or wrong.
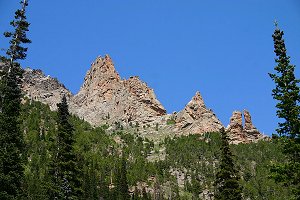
[0,0,31,199]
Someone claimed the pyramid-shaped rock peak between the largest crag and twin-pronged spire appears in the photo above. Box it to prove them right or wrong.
[175,92,223,133]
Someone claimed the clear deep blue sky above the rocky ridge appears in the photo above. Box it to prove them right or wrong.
[0,0,300,134]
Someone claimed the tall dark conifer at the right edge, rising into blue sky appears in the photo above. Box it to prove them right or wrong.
[269,23,300,199]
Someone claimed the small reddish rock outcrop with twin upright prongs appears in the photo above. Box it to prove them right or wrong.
[226,110,266,143]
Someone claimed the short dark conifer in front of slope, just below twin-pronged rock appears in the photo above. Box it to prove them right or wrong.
[215,128,242,200]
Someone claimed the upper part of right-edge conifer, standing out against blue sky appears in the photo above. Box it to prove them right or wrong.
[269,23,300,138]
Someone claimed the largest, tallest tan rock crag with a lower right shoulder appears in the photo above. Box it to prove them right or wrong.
[71,55,166,125]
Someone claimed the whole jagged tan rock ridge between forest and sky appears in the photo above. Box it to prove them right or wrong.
[22,55,263,143]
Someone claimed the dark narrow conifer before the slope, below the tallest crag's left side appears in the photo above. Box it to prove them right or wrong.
[49,96,82,199]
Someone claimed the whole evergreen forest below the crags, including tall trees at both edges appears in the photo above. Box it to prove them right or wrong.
[0,0,300,200]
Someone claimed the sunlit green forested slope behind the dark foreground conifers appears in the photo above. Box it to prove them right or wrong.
[21,100,291,199]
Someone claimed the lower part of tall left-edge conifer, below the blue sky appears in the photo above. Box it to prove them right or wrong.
[0,63,25,199]
